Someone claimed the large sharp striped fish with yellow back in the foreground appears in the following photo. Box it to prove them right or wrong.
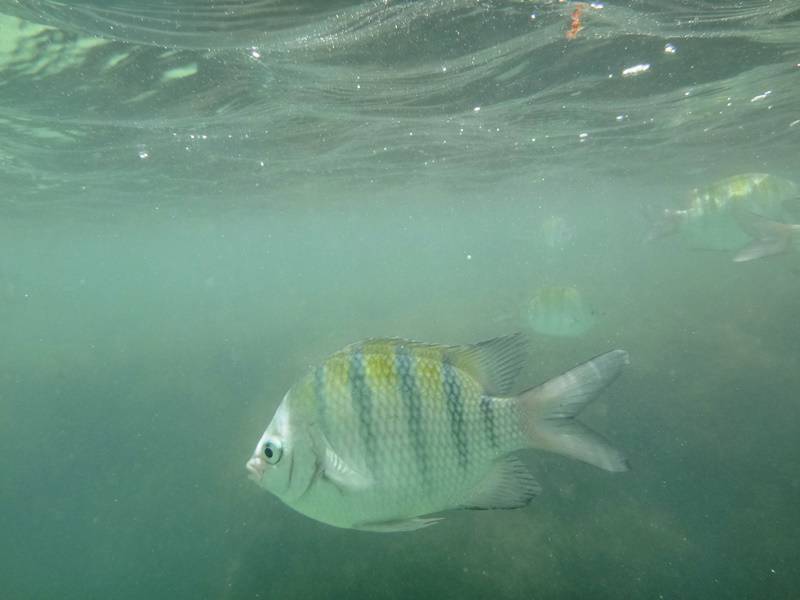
[246,333,629,533]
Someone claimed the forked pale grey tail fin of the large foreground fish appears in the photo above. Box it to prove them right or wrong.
[519,350,630,471]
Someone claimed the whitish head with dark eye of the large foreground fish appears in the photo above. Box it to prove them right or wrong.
[246,392,315,504]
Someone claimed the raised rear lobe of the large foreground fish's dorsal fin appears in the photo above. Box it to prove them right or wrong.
[446,333,528,396]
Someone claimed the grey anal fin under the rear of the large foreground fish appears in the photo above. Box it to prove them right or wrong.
[461,456,542,510]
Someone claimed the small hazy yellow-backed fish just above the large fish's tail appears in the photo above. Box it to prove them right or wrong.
[526,286,595,337]
